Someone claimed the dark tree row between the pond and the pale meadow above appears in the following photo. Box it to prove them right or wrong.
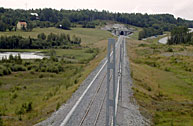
[0,33,81,49]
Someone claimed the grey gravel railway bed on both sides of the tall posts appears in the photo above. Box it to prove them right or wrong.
[35,37,149,126]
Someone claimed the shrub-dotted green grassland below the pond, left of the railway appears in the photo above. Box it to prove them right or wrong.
[0,48,97,125]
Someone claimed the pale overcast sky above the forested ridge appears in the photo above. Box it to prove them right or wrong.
[0,0,193,20]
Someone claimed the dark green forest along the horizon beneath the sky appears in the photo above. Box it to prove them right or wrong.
[0,8,193,31]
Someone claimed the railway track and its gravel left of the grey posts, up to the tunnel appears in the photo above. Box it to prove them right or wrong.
[36,37,124,126]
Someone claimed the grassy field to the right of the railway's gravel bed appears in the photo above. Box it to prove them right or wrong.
[127,39,193,126]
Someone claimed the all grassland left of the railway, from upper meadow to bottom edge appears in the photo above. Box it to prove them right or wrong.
[0,28,112,126]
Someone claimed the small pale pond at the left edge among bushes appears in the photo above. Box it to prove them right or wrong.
[0,52,47,60]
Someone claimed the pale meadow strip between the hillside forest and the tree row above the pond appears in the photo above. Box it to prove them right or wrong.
[0,27,112,45]
